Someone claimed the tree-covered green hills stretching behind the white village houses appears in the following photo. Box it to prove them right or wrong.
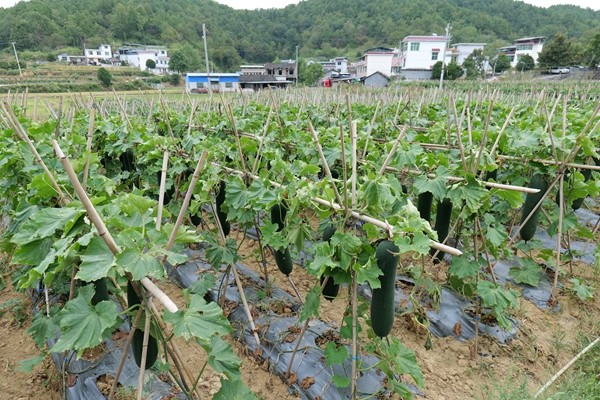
[0,0,600,69]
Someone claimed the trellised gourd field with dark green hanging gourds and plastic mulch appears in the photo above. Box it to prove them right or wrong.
[0,85,600,399]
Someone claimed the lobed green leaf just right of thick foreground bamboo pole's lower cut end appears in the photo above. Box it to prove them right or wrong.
[164,290,232,343]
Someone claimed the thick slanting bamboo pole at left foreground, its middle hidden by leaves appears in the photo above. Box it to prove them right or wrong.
[52,140,178,312]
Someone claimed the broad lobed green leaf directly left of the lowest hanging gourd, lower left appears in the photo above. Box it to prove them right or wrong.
[51,285,119,356]
